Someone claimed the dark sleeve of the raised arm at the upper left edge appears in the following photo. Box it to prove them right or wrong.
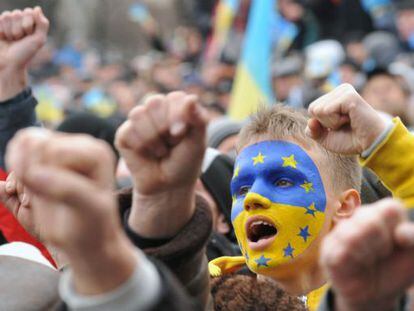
[0,88,37,169]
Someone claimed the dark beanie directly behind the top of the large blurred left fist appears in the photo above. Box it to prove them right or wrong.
[56,112,119,159]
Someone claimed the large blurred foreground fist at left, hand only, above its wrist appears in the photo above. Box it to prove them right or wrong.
[6,128,120,253]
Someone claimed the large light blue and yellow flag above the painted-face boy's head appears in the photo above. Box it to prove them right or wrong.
[229,0,278,119]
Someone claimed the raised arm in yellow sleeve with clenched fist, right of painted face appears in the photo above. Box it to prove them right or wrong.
[307,84,414,207]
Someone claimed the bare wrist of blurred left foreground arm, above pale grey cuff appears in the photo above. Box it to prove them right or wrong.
[66,232,137,295]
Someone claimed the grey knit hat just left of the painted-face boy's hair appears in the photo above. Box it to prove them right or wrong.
[207,117,243,148]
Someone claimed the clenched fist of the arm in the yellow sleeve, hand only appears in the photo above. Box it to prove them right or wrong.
[306,84,387,154]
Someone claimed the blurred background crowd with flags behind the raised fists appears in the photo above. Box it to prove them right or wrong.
[0,0,414,146]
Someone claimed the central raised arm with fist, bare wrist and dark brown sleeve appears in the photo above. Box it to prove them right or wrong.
[116,92,211,305]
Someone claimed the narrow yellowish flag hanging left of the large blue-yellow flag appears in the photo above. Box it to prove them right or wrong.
[208,0,240,58]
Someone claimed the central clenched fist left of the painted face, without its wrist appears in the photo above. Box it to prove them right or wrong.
[116,92,207,195]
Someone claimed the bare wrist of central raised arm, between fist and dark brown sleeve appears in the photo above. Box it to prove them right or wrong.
[128,187,195,239]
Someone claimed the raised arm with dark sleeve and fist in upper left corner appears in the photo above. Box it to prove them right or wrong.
[0,7,49,169]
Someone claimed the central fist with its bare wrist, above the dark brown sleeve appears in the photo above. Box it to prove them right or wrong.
[116,92,207,238]
